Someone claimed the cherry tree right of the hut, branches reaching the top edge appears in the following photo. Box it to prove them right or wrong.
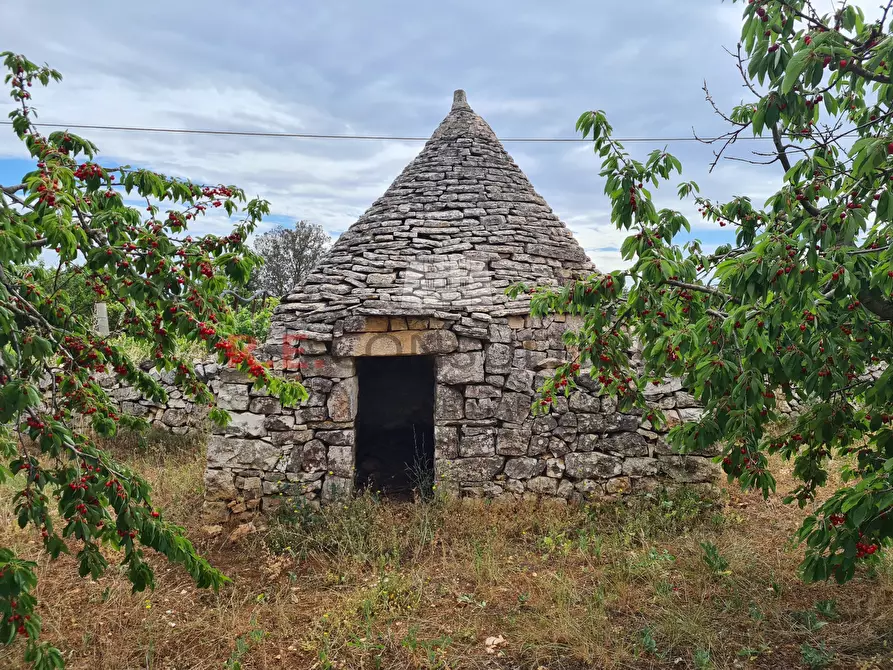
[515,0,893,582]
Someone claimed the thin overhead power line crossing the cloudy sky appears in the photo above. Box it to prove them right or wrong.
[0,121,772,143]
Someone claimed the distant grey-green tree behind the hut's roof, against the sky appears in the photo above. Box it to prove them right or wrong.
[249,221,331,297]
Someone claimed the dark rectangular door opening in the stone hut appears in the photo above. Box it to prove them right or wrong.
[356,356,434,495]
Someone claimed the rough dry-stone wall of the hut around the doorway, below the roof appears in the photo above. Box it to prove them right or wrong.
[205,314,718,521]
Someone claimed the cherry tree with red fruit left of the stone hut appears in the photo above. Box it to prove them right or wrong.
[0,52,306,668]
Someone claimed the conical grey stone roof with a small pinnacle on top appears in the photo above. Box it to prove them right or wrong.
[274,90,594,330]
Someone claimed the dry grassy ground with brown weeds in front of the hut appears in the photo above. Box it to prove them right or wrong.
[0,436,893,670]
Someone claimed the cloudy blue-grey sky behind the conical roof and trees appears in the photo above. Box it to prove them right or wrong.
[0,0,860,271]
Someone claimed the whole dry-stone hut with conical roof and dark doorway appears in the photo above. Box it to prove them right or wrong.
[206,91,713,520]
